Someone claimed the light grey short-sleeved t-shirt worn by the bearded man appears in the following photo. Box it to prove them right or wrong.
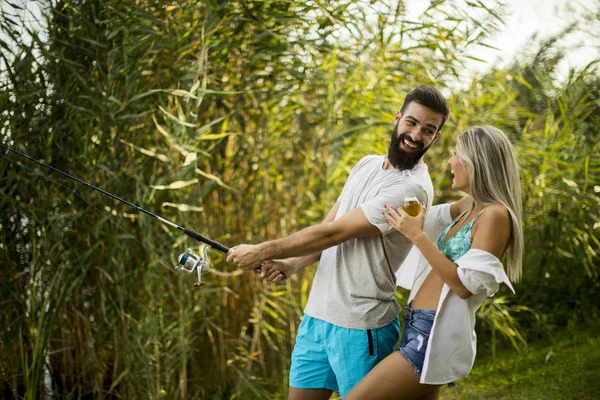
[304,156,433,330]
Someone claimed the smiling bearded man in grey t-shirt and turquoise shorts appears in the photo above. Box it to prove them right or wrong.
[227,85,450,400]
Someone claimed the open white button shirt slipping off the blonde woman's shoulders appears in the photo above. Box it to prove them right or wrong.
[396,204,514,385]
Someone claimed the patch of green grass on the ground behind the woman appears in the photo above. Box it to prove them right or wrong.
[441,324,600,400]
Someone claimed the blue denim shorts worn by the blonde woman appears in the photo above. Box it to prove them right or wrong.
[398,306,435,375]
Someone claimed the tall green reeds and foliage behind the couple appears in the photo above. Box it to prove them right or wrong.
[0,0,600,398]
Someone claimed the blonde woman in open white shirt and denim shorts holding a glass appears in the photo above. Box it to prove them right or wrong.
[346,126,523,400]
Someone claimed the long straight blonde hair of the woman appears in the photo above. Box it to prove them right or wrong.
[455,126,523,282]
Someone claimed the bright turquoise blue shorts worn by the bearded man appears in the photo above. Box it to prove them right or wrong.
[290,315,400,398]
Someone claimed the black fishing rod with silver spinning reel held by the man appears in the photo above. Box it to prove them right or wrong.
[0,143,229,286]
